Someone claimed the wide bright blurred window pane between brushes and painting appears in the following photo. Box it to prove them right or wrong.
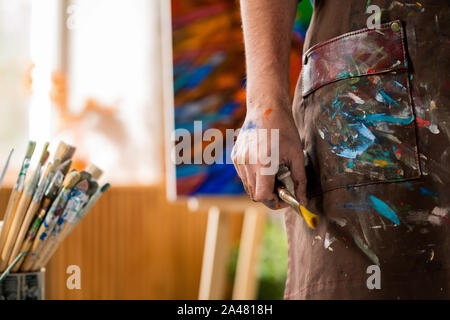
[57,0,163,185]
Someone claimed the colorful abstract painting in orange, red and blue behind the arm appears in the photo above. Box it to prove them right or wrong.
[168,0,312,196]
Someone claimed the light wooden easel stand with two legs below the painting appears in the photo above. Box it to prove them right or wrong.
[188,197,267,300]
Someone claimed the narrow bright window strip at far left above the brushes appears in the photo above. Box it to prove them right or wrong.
[0,0,32,185]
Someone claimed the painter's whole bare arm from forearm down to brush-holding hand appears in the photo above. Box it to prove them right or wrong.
[232,0,306,209]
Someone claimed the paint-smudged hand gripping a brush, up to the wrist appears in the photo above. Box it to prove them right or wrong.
[232,102,307,209]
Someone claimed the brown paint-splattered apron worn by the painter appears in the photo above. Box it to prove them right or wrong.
[285,0,450,299]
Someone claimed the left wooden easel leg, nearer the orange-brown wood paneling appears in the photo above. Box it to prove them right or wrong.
[198,207,230,300]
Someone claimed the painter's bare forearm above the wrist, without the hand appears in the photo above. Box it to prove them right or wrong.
[241,0,298,108]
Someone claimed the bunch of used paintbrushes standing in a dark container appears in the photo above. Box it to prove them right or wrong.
[0,141,109,299]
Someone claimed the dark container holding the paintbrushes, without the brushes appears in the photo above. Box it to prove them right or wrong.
[0,269,45,300]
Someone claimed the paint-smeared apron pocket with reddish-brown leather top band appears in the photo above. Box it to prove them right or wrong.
[301,21,421,192]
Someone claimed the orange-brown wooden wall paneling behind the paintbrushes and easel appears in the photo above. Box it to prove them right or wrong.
[0,186,246,299]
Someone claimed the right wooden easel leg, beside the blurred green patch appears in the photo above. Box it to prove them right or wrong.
[233,207,266,300]
